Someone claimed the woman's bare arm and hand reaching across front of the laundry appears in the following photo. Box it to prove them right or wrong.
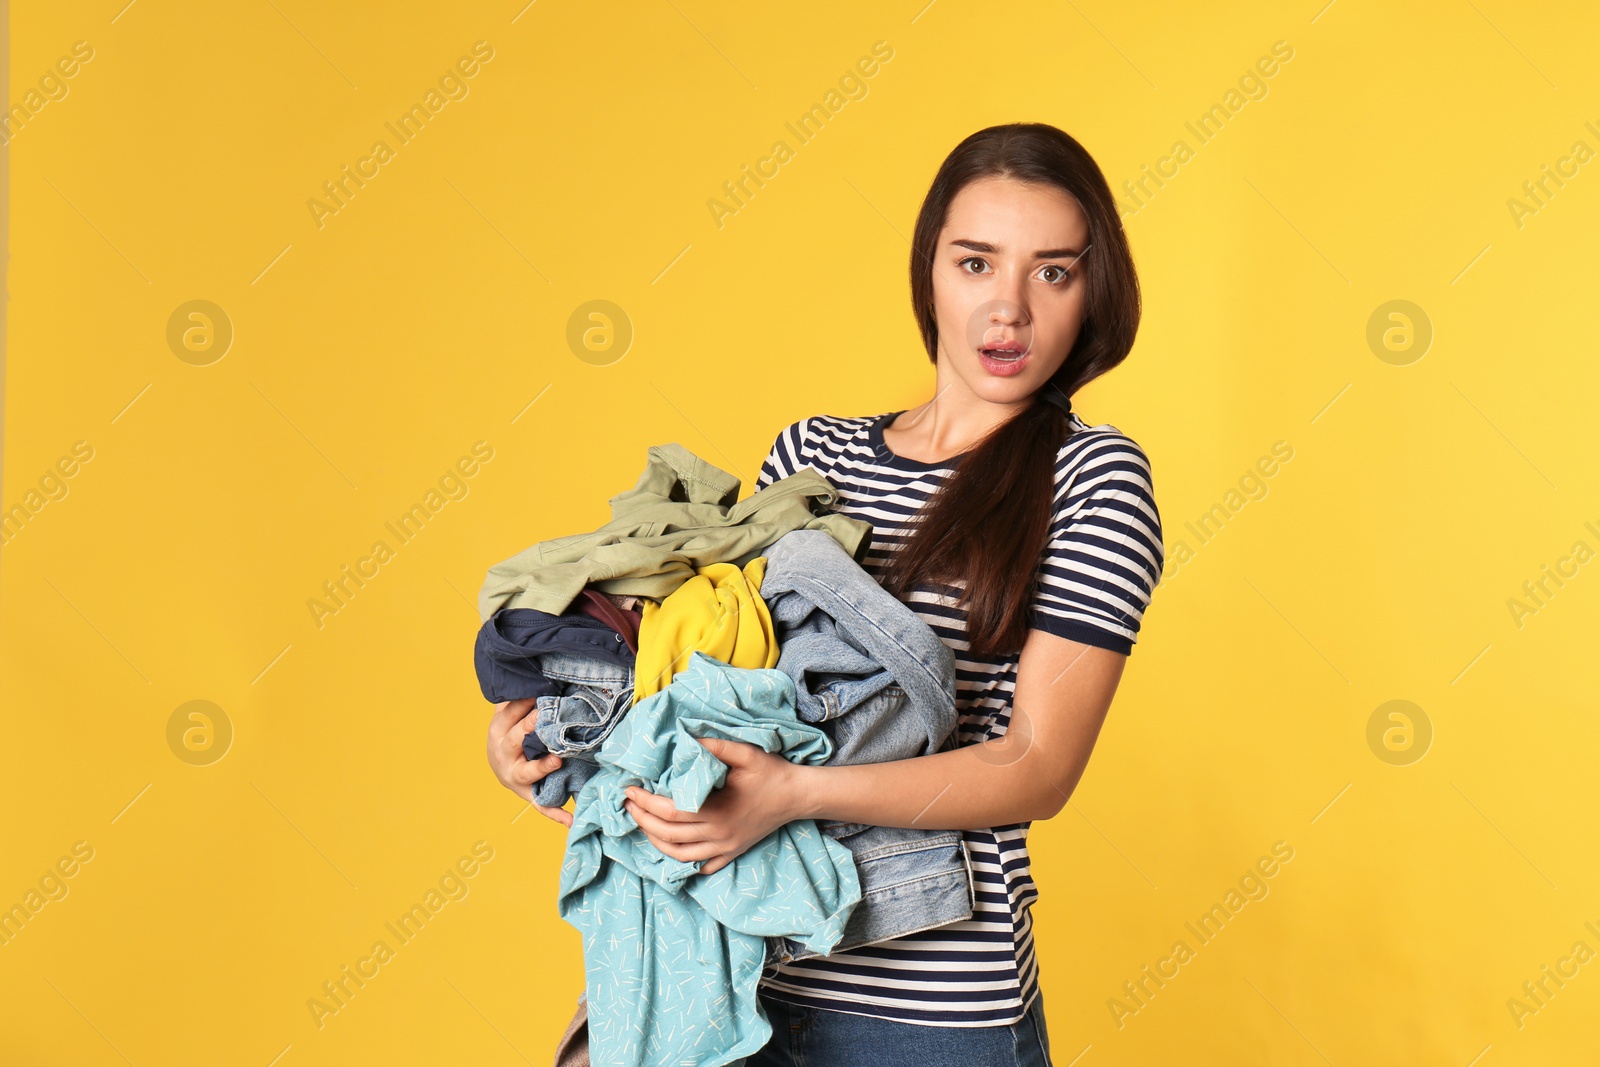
[627,630,1128,873]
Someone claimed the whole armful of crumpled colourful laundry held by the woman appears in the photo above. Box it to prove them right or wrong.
[474,445,973,1067]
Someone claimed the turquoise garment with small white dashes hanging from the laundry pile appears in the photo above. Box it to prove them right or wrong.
[558,651,861,1067]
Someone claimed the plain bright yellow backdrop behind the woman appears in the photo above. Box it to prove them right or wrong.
[0,0,1600,1067]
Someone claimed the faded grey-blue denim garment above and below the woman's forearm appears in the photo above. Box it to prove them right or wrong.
[748,530,976,961]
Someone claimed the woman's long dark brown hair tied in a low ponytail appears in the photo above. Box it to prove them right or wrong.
[882,122,1139,656]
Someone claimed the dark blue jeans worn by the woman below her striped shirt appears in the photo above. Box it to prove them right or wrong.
[734,993,1050,1067]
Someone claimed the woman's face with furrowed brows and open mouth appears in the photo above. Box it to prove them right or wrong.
[933,178,1093,403]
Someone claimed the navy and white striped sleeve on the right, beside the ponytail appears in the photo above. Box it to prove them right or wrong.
[1030,432,1165,656]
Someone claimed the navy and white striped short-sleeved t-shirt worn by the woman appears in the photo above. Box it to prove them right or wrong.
[755,411,1163,1027]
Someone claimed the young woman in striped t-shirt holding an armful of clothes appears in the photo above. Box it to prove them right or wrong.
[490,123,1163,1067]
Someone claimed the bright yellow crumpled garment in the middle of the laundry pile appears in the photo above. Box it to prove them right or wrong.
[634,556,787,704]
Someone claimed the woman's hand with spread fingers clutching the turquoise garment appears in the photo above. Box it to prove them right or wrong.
[624,737,803,875]
